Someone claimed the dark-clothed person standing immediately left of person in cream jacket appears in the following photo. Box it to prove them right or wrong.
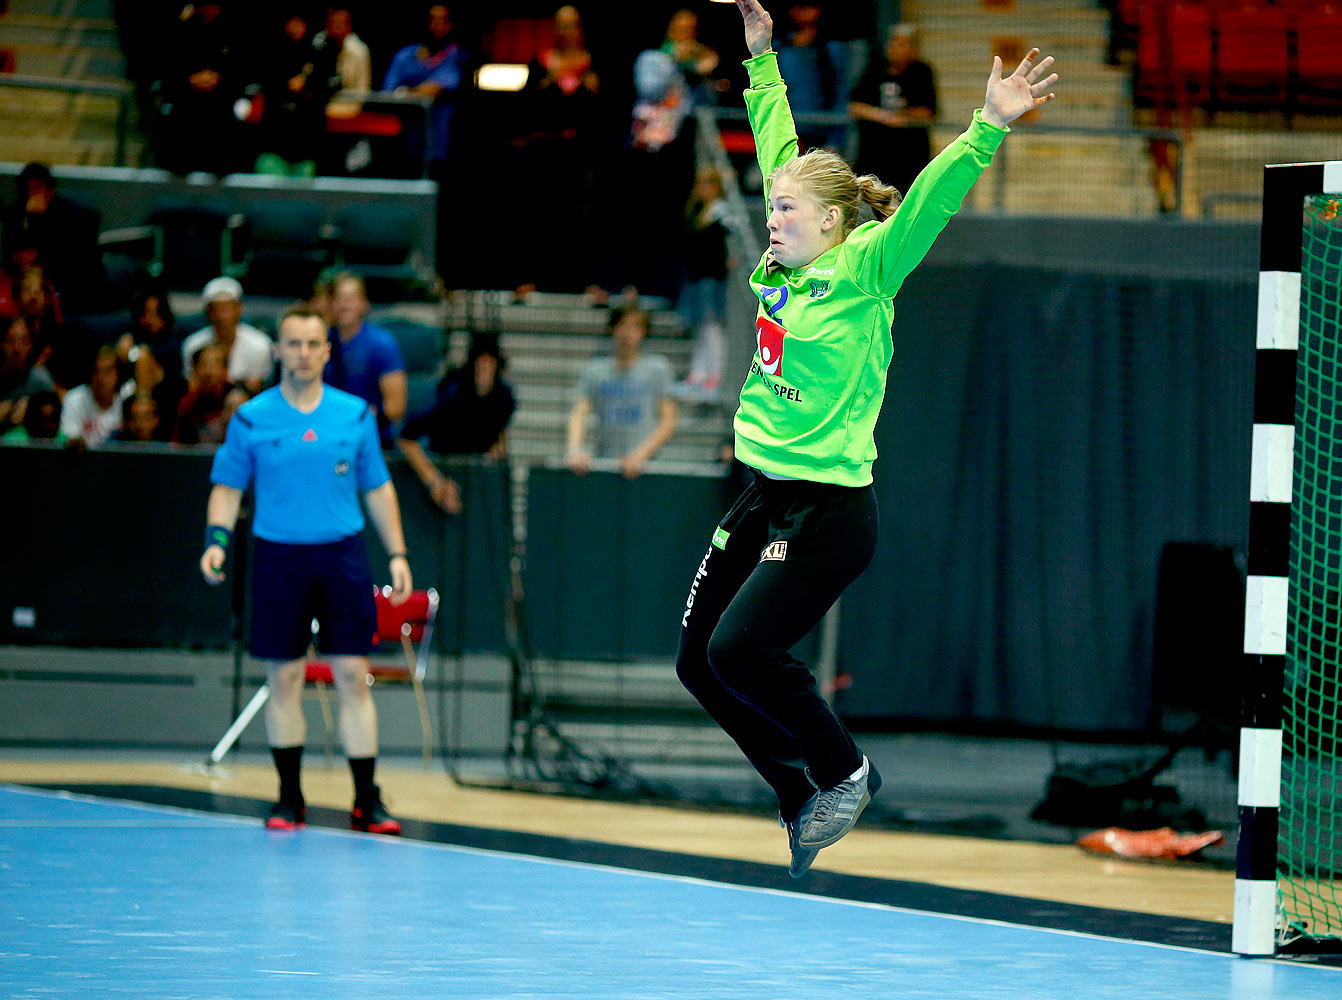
[256,12,338,177]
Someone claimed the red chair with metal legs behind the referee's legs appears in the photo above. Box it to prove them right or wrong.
[209,587,439,765]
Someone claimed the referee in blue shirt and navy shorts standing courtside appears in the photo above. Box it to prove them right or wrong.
[200,307,412,834]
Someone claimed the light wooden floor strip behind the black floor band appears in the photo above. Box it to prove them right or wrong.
[0,752,1235,922]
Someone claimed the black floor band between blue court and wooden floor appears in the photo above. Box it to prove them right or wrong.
[20,783,1231,952]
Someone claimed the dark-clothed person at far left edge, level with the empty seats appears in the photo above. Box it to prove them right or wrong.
[0,162,105,305]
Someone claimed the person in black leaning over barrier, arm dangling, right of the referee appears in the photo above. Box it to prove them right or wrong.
[396,333,517,514]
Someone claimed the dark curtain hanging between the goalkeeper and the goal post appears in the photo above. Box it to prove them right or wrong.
[839,264,1256,730]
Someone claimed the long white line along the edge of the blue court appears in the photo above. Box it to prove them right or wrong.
[0,784,1342,976]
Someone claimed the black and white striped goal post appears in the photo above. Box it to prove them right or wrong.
[1231,162,1342,954]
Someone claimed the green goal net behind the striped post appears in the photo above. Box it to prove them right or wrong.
[1278,195,1342,942]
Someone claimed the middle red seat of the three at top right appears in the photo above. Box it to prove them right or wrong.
[1216,4,1288,105]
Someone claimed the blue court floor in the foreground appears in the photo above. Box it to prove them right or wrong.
[0,787,1342,1000]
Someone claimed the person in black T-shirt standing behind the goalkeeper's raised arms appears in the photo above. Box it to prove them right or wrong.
[848,24,937,192]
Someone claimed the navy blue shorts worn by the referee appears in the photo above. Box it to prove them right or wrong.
[250,534,377,660]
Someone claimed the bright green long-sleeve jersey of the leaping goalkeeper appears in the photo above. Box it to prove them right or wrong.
[734,52,1008,486]
